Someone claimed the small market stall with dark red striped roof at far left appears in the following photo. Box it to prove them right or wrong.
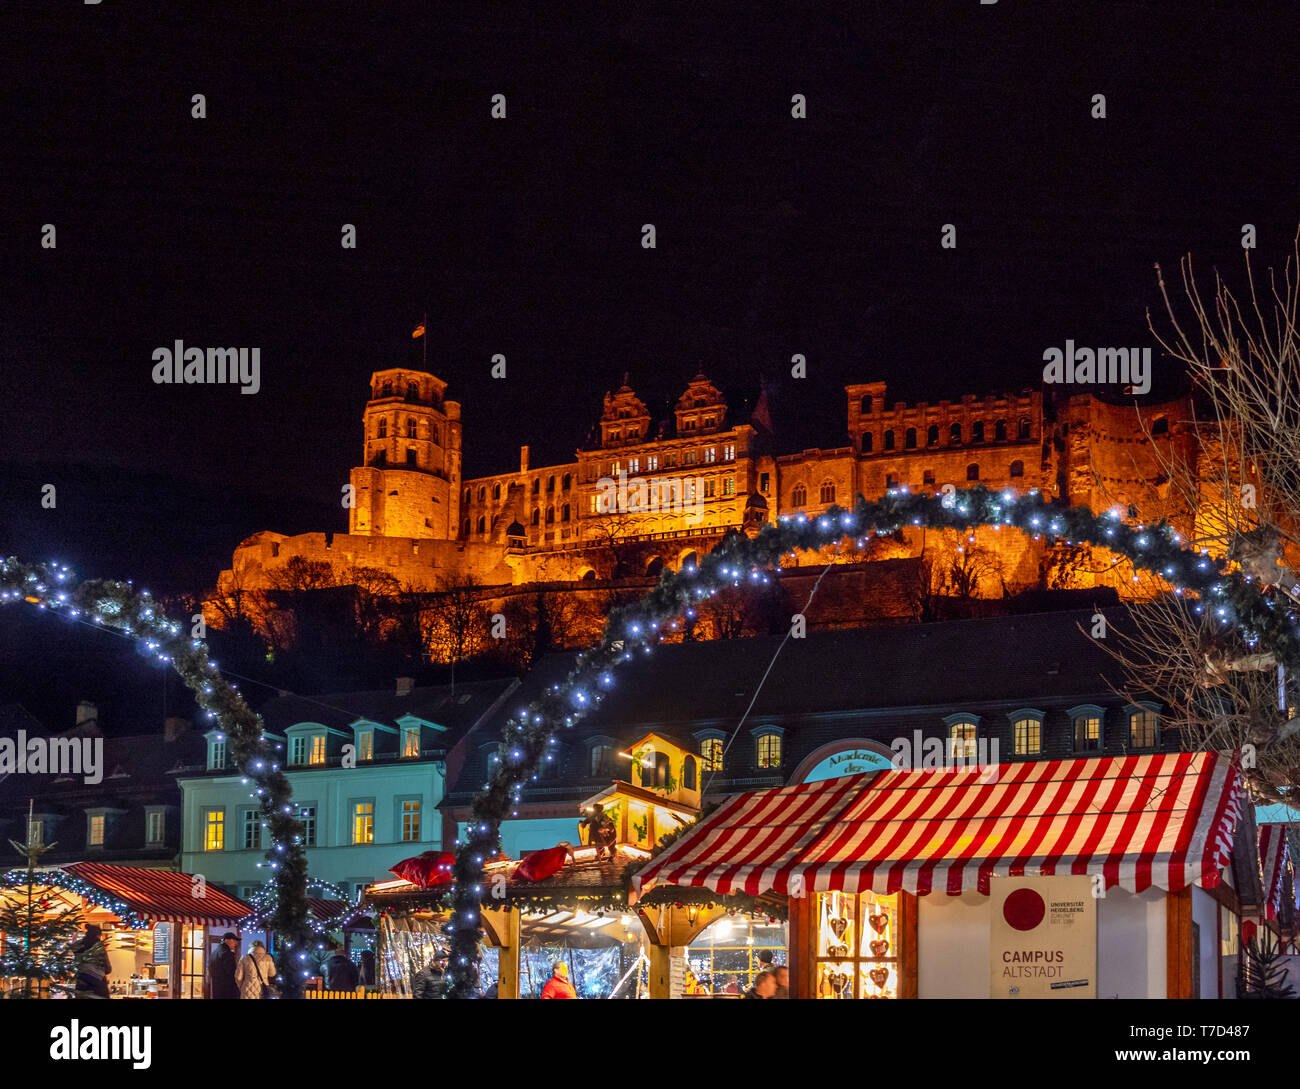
[0,862,248,998]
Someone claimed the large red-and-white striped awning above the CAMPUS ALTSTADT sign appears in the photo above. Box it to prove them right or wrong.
[637,752,1244,895]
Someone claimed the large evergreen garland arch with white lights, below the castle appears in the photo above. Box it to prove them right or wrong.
[447,486,1300,998]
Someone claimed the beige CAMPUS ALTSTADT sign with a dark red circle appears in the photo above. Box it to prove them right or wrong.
[989,876,1097,998]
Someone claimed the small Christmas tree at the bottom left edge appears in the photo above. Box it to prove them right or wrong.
[0,807,85,998]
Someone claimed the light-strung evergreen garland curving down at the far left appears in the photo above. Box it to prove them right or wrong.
[0,556,312,998]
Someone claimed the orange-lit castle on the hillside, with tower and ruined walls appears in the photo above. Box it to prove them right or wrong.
[218,368,1192,605]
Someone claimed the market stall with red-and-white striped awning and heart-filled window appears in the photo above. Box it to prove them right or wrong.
[633,752,1258,998]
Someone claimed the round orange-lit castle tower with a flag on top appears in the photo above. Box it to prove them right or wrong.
[348,366,460,541]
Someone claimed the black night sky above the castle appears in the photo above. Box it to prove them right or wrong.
[0,8,1297,722]
